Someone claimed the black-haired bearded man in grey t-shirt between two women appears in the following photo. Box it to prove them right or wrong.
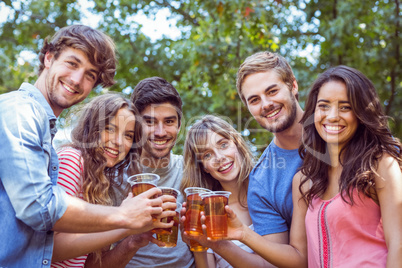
[90,77,195,268]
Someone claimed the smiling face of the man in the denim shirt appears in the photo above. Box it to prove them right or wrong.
[38,47,98,116]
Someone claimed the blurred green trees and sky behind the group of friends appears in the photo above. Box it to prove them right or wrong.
[0,0,402,156]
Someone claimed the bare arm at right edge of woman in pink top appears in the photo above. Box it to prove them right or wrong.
[375,155,402,268]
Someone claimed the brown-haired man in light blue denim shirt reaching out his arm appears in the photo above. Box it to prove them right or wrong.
[0,25,170,267]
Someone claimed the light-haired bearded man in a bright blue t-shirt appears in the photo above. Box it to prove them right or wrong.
[236,52,303,266]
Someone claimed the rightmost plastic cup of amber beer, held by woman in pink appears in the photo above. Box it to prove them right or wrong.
[200,191,231,240]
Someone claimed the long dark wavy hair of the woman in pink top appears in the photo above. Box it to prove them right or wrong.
[299,66,402,204]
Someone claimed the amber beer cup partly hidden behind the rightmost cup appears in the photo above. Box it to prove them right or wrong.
[184,187,211,236]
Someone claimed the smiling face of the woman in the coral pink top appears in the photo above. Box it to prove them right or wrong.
[314,81,359,150]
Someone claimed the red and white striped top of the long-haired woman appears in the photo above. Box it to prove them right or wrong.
[51,147,88,268]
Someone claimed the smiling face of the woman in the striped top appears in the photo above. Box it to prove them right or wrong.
[101,108,135,167]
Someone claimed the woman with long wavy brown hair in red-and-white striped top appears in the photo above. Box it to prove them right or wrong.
[51,94,170,268]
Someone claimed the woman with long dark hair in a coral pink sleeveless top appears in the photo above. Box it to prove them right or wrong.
[212,66,402,268]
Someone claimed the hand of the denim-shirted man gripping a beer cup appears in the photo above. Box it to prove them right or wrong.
[119,187,168,234]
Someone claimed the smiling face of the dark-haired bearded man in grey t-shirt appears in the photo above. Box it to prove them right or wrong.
[141,102,180,163]
